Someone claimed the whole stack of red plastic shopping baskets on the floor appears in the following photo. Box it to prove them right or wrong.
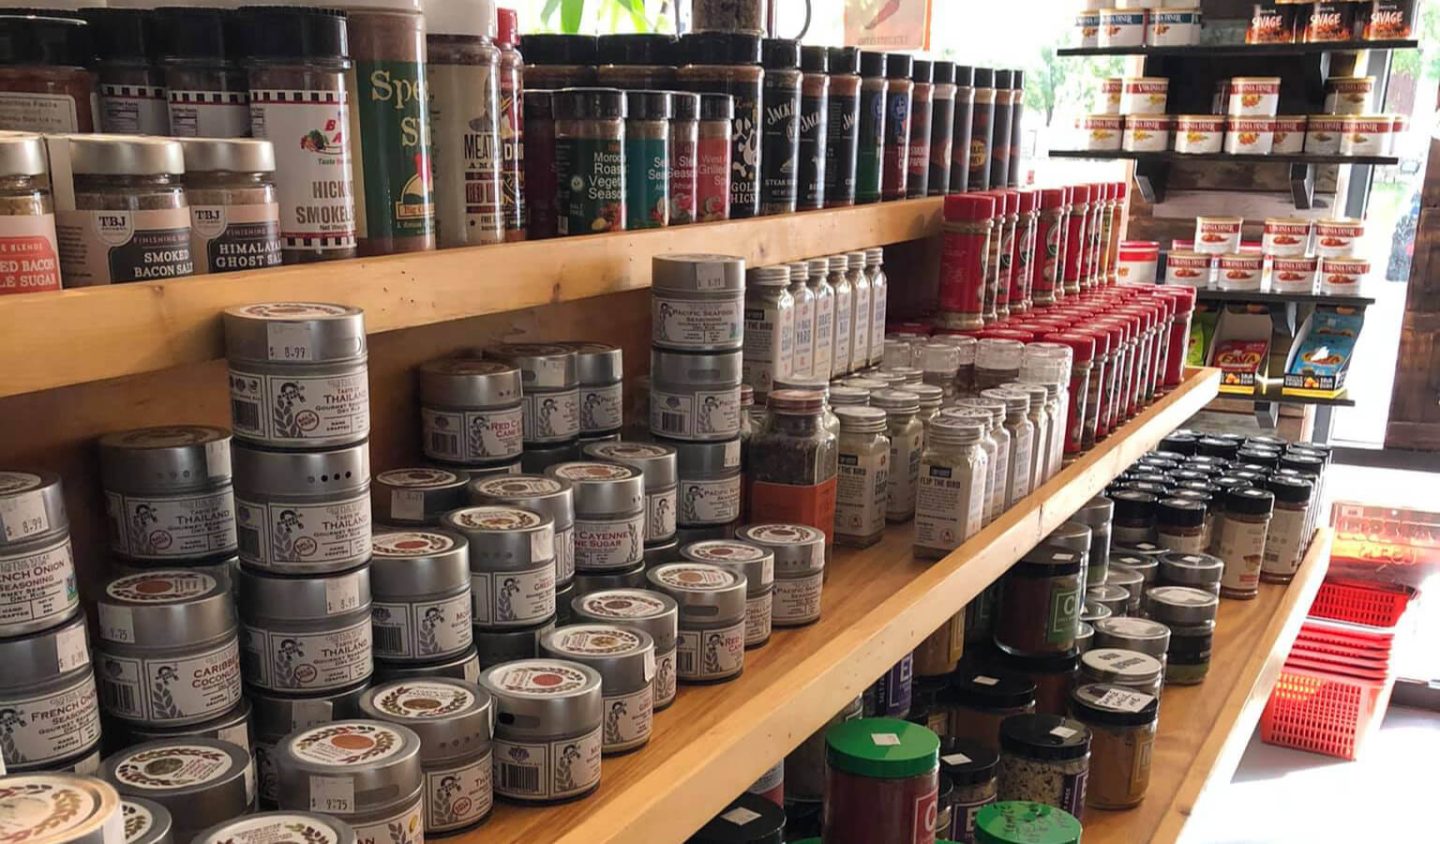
[1260,580,1411,759]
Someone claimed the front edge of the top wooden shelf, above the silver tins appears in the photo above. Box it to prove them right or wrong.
[0,197,942,398]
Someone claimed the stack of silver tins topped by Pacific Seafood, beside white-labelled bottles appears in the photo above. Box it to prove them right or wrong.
[649,255,744,546]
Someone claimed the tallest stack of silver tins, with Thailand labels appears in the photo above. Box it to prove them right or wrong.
[223,302,374,805]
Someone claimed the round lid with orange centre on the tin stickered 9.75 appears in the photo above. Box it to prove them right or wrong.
[275,719,423,817]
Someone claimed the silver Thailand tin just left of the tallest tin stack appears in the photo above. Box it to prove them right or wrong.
[99,425,236,560]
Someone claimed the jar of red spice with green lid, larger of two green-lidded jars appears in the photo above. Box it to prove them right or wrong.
[822,719,940,844]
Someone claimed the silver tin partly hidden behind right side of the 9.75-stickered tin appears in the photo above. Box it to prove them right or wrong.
[360,678,495,834]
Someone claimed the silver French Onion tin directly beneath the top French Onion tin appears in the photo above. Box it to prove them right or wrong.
[0,614,99,771]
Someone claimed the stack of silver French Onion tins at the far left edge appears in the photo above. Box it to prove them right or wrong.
[0,471,101,773]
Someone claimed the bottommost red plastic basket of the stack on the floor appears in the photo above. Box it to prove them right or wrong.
[1260,665,1395,759]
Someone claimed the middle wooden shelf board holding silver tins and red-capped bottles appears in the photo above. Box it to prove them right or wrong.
[456,369,1220,844]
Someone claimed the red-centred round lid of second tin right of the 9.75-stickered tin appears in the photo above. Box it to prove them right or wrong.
[480,657,605,737]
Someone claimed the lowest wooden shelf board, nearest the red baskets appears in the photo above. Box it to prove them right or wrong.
[1084,527,1333,844]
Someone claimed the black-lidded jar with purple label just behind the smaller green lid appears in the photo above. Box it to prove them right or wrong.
[982,714,1090,817]
